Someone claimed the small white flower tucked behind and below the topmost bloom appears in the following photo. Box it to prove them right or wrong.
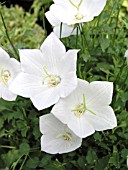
[45,11,80,38]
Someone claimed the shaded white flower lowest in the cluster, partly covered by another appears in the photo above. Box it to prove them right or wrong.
[40,114,82,154]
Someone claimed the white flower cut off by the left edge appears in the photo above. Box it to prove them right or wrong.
[0,48,20,101]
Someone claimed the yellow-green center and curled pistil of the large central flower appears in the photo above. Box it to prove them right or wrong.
[42,66,61,87]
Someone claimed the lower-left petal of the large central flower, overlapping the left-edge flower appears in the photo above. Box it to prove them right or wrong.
[9,73,43,97]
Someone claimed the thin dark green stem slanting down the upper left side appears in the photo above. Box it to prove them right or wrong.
[0,11,19,60]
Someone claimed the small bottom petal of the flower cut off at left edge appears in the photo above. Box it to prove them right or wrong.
[2,86,17,101]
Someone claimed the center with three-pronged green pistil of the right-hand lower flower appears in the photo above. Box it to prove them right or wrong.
[72,94,96,118]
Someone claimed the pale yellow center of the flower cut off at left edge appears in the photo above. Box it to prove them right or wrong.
[0,67,11,85]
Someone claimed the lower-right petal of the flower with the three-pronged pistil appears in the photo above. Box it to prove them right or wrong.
[87,106,117,131]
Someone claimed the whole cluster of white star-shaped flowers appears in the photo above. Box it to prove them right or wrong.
[0,0,127,154]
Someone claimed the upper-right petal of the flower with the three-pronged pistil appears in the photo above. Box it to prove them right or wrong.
[86,81,113,106]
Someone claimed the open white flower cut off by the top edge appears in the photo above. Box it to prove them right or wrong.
[47,0,107,25]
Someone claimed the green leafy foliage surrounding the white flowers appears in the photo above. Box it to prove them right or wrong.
[0,0,128,170]
